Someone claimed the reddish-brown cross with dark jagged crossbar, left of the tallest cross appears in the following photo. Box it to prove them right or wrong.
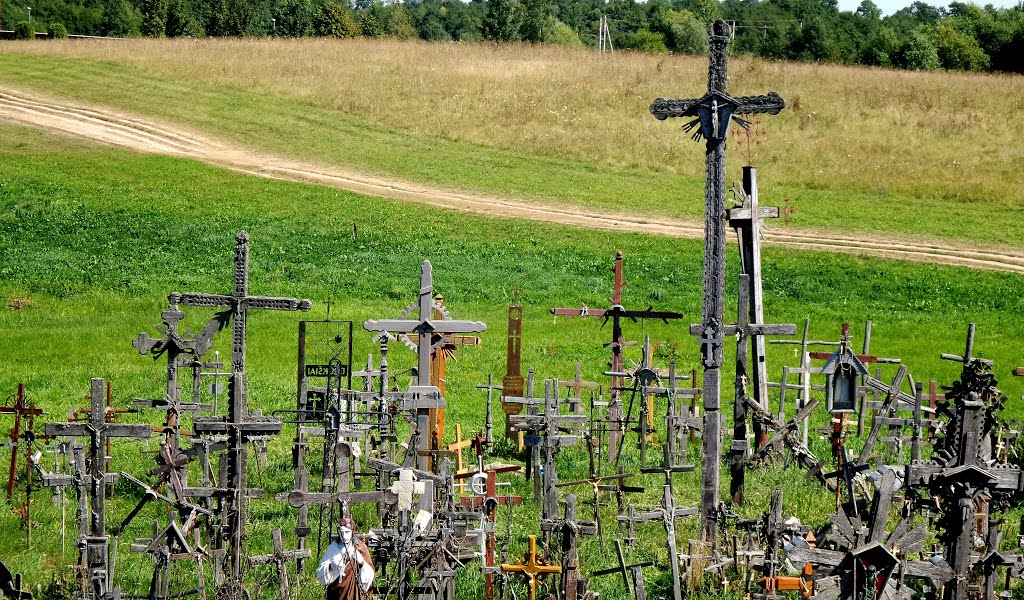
[551,250,683,459]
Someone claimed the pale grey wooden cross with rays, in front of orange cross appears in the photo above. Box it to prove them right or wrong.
[362,260,487,470]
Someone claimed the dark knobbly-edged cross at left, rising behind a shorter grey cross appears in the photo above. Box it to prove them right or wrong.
[179,231,312,373]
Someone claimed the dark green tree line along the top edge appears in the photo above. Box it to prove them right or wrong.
[0,0,1024,73]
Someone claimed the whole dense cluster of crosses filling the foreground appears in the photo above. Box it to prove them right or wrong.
[6,17,1024,600]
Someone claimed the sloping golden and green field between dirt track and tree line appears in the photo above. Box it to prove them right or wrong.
[0,39,1024,247]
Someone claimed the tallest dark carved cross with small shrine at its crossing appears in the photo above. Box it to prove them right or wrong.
[650,19,785,540]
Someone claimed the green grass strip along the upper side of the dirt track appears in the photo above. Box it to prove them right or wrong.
[0,46,1024,247]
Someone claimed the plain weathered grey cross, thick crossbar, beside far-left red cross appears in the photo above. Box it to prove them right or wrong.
[45,378,151,599]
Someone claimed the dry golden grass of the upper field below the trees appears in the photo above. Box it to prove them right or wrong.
[8,39,1024,208]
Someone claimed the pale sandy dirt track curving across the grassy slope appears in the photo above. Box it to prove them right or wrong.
[0,87,1024,273]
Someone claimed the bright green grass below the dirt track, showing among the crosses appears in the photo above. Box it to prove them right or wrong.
[0,126,1024,598]
